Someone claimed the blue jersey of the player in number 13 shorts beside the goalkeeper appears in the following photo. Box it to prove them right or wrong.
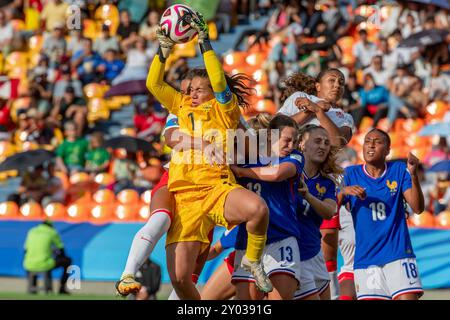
[236,151,305,250]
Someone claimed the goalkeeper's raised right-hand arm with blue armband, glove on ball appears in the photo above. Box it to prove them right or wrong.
[191,12,232,104]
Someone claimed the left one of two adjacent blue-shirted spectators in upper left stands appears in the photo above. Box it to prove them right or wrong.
[71,38,102,85]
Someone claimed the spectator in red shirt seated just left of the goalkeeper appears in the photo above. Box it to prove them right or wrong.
[133,98,166,141]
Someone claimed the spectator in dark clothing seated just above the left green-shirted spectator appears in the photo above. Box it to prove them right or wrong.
[51,86,88,136]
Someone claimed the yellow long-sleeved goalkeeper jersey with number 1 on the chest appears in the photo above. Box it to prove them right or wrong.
[147,51,241,191]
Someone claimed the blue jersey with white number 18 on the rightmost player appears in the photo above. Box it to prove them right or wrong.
[343,161,415,269]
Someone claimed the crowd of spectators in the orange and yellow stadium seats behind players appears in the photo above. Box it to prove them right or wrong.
[0,0,450,222]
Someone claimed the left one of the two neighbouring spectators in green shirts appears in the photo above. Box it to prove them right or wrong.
[56,121,89,174]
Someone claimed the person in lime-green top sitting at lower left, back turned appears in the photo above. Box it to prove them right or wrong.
[23,220,72,294]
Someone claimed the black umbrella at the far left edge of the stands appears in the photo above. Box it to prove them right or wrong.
[0,149,55,171]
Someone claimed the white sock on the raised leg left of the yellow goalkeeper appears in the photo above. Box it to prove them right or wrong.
[122,209,171,276]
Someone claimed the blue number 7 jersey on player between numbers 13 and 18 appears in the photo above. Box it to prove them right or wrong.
[297,172,336,261]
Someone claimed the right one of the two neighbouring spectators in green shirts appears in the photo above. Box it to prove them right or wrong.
[85,132,111,175]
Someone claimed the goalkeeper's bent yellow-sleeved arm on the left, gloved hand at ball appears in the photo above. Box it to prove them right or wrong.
[146,27,183,114]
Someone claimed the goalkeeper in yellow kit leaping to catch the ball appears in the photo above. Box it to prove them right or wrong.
[147,14,272,299]
